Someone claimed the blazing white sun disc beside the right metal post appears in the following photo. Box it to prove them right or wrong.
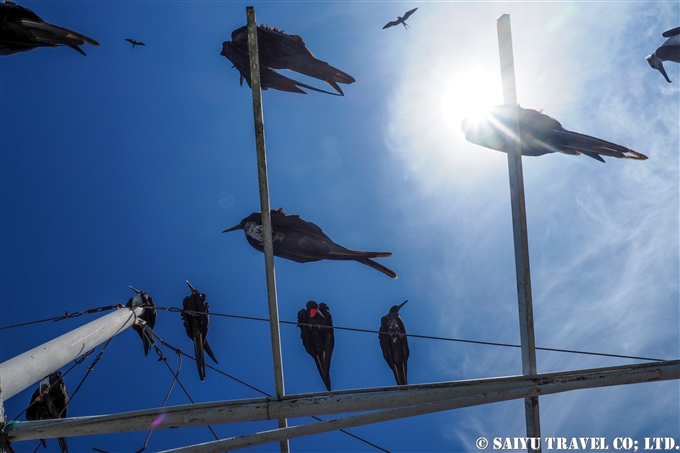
[441,69,503,136]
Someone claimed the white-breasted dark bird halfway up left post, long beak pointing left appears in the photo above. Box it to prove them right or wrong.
[222,208,397,278]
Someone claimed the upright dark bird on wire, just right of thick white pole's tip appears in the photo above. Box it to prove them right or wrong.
[182,280,217,381]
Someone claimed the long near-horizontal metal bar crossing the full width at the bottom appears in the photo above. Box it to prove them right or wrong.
[9,360,680,444]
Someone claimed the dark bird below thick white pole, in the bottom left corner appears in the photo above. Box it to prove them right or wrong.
[26,371,68,453]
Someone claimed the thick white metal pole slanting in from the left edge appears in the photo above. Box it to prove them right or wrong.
[0,307,144,400]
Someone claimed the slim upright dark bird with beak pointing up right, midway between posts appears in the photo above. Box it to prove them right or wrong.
[378,300,410,385]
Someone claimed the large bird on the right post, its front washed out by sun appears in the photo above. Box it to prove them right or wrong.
[462,105,647,162]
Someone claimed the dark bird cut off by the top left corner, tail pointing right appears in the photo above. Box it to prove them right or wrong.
[0,1,99,55]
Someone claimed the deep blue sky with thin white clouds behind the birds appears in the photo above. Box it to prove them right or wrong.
[0,1,680,452]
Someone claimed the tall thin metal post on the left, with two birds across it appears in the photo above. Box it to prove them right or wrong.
[246,6,289,453]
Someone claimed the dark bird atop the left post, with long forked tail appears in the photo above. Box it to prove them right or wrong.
[220,25,355,96]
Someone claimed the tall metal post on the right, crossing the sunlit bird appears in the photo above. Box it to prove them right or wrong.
[496,14,541,446]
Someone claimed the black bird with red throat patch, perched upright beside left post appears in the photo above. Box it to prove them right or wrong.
[298,300,335,392]
